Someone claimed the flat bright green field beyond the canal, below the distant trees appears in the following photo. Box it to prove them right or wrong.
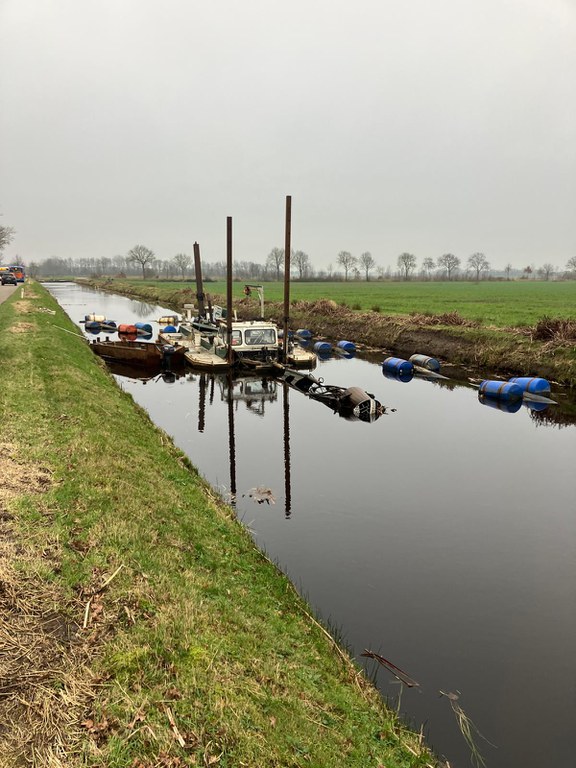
[109,280,576,327]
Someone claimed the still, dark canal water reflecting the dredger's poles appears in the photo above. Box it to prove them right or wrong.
[49,284,576,768]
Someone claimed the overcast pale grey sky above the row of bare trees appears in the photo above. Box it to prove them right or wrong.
[0,0,576,268]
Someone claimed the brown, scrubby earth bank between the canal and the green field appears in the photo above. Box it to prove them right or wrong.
[78,279,576,388]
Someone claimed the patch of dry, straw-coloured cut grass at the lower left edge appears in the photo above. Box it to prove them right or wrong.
[0,444,93,768]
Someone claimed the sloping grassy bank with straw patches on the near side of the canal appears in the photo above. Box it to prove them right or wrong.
[0,284,432,768]
